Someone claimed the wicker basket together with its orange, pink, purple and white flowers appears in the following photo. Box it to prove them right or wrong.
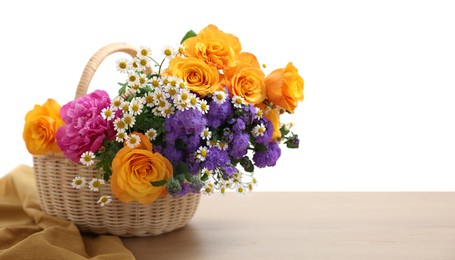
[23,25,304,236]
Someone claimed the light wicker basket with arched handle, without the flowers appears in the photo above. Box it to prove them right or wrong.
[33,43,200,237]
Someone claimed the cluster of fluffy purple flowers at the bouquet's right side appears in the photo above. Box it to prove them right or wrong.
[159,90,281,196]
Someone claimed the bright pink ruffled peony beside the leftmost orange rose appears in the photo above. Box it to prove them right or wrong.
[56,90,115,163]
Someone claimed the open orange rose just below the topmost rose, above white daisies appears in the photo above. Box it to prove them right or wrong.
[167,57,221,97]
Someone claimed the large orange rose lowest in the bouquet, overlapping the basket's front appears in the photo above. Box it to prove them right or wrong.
[111,133,173,204]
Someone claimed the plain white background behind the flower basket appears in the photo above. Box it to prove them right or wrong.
[0,0,455,191]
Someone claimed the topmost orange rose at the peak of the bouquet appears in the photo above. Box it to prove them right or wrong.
[183,25,242,69]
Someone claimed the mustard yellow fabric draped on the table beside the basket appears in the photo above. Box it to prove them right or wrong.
[0,165,135,260]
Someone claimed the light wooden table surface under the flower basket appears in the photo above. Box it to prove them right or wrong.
[123,192,455,260]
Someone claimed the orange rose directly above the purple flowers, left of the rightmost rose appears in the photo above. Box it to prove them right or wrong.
[226,63,266,104]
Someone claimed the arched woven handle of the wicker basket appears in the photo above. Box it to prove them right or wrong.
[74,43,137,99]
